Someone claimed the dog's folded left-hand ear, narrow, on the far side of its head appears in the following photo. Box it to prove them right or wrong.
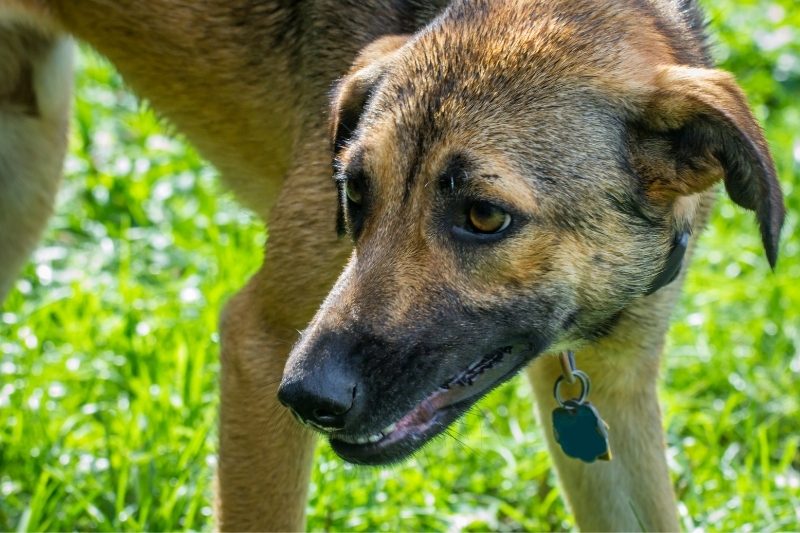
[330,35,408,157]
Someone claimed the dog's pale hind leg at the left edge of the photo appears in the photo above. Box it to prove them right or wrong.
[0,6,72,302]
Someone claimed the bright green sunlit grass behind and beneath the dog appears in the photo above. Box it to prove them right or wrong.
[0,0,800,531]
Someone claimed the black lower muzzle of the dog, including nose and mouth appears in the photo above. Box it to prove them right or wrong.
[278,322,547,464]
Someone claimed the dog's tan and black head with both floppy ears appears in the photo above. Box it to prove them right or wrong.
[279,2,783,463]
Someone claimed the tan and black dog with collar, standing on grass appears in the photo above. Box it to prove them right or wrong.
[0,0,784,530]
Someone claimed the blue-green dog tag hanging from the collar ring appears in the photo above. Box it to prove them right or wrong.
[553,400,611,463]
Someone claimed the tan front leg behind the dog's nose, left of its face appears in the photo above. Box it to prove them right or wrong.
[218,139,349,531]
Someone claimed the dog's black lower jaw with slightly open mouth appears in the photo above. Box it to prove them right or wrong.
[329,344,541,465]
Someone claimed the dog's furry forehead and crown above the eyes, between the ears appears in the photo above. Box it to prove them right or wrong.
[362,2,671,191]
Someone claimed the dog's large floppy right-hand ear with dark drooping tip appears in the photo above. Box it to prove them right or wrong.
[631,66,785,268]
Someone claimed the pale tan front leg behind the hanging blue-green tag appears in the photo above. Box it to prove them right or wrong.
[528,302,678,531]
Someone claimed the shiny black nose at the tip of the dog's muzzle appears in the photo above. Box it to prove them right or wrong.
[278,375,356,431]
